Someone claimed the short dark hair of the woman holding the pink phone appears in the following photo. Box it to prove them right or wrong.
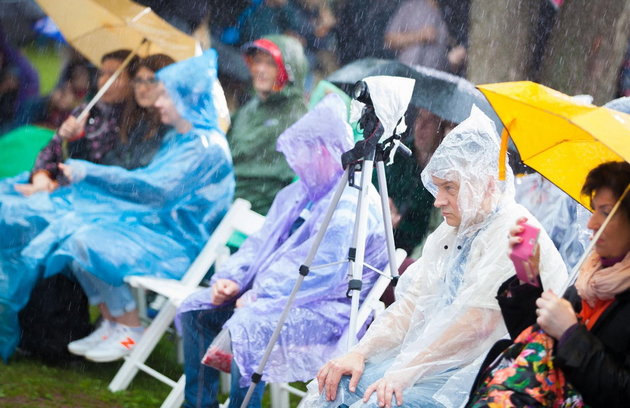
[582,162,630,220]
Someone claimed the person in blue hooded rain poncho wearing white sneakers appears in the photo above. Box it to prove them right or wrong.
[0,50,234,361]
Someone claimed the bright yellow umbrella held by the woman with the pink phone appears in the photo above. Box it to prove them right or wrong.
[477,81,630,208]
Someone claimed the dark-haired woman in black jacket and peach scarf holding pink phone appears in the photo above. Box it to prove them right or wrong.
[468,162,630,407]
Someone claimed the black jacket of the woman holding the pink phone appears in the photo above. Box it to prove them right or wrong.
[473,277,630,408]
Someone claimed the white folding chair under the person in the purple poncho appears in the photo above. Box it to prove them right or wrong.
[269,248,407,408]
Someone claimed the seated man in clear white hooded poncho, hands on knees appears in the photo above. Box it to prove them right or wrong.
[303,107,567,408]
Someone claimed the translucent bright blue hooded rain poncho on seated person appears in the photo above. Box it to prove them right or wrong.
[0,51,234,358]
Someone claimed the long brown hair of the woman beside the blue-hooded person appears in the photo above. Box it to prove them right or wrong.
[120,54,175,144]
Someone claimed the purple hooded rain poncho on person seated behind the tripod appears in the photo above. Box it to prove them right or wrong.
[179,95,387,386]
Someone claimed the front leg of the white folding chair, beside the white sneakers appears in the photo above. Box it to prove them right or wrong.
[109,301,177,392]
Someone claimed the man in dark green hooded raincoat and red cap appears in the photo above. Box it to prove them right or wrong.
[227,35,307,214]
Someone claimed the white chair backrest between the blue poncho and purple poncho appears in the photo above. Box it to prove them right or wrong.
[181,198,265,287]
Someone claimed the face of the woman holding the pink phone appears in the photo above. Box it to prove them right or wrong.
[587,187,630,258]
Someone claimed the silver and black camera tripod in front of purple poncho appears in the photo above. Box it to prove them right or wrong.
[241,87,411,408]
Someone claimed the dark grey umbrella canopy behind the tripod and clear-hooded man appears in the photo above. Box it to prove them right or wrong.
[326,58,501,125]
